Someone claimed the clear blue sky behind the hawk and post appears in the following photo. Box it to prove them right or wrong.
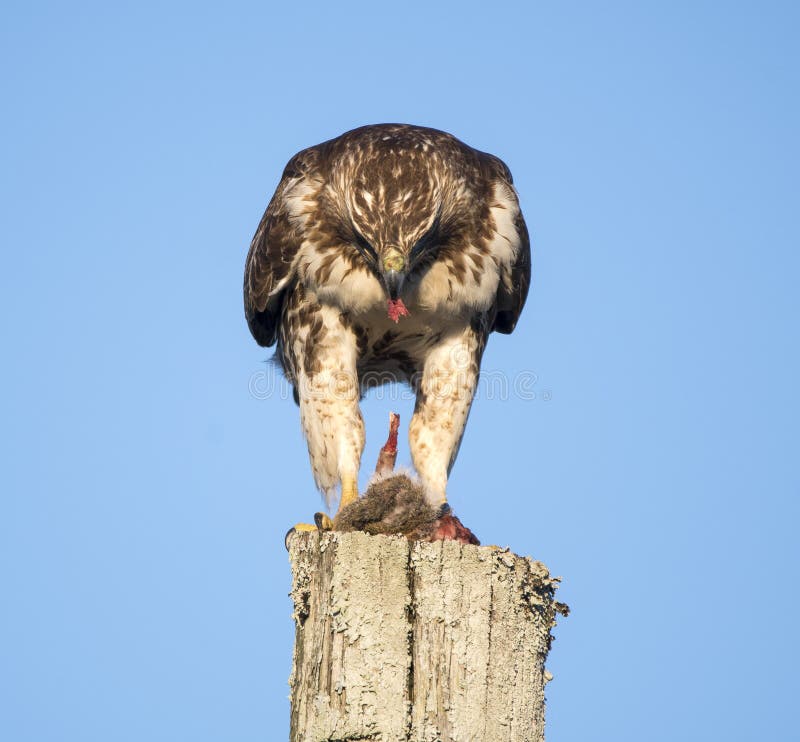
[0,0,800,742]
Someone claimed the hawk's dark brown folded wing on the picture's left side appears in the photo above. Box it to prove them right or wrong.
[244,150,317,346]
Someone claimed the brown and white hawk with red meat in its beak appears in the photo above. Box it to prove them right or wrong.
[244,124,531,528]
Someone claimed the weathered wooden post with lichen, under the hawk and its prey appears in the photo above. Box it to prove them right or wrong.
[289,532,567,742]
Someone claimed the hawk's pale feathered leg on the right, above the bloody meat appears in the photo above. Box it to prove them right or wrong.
[408,328,483,507]
